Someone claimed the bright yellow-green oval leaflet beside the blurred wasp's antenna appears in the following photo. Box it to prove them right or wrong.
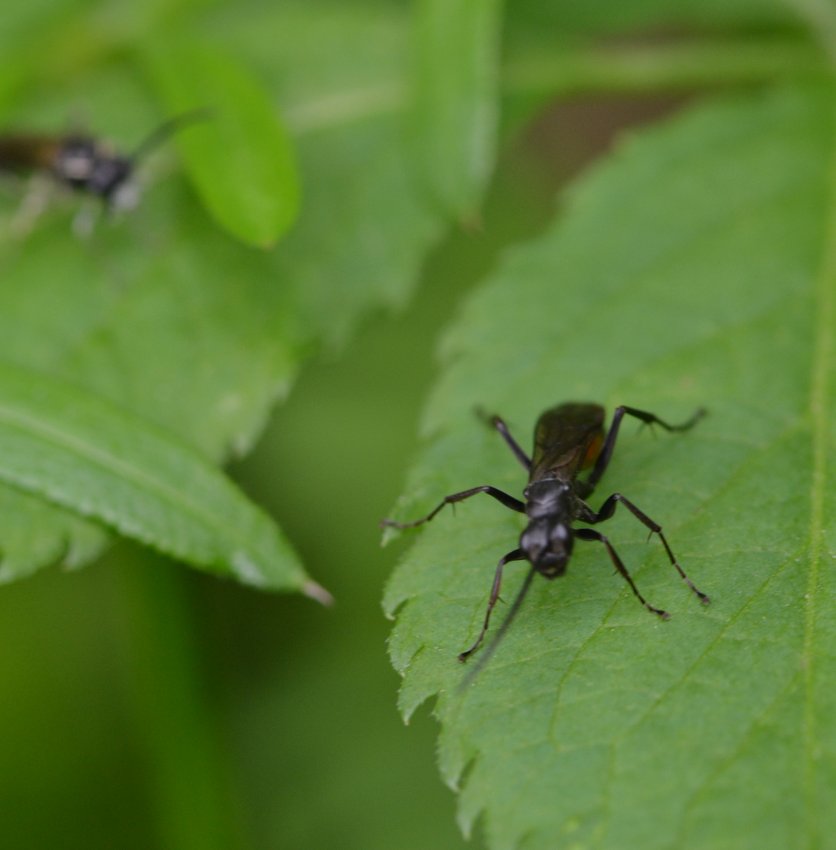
[147,36,299,246]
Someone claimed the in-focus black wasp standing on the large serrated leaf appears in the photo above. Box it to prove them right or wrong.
[383,402,709,661]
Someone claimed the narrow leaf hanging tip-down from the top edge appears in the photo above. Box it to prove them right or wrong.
[410,0,502,219]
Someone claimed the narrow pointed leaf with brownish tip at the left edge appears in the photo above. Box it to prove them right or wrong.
[0,364,316,595]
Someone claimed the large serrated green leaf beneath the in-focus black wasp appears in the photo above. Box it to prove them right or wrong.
[385,87,836,850]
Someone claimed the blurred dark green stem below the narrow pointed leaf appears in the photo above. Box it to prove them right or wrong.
[119,547,241,850]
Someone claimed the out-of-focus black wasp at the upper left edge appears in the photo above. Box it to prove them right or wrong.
[0,110,207,227]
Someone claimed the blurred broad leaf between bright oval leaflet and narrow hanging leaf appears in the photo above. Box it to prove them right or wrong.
[209,0,447,347]
